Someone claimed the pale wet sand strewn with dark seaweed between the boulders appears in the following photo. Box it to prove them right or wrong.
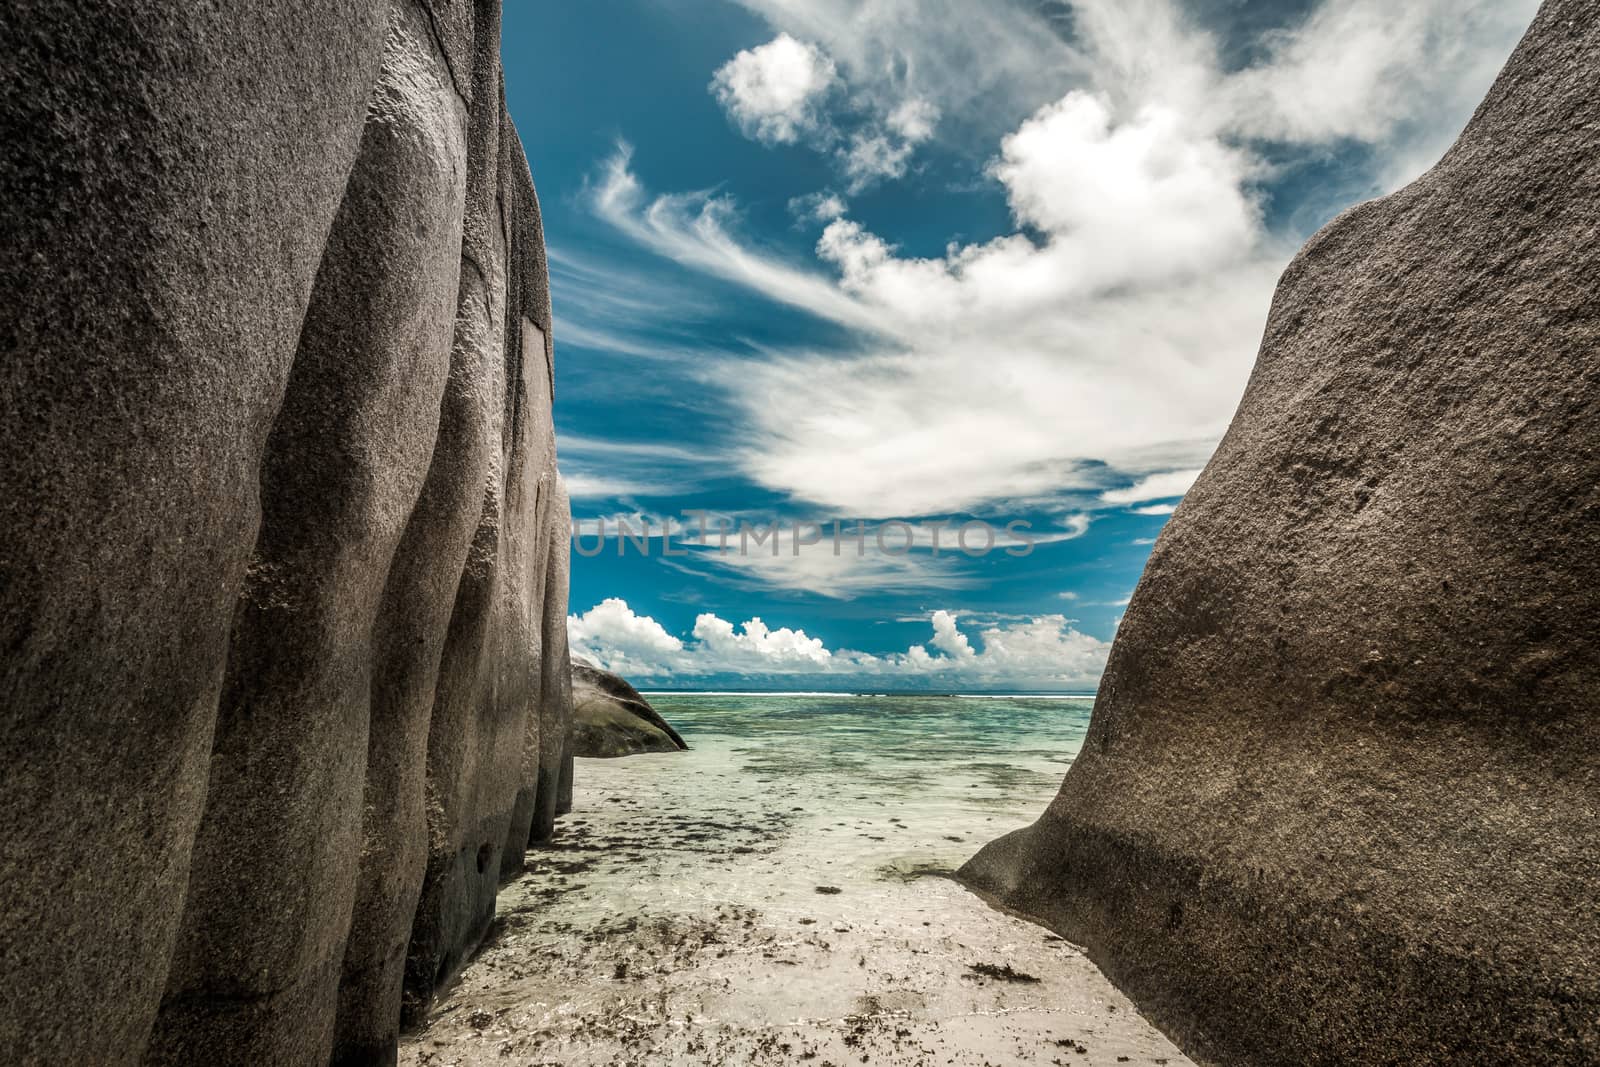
[400,700,1189,1067]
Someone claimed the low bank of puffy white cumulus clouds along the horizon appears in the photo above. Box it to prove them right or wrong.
[566,598,1110,688]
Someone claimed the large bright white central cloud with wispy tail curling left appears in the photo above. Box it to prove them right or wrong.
[603,94,1277,515]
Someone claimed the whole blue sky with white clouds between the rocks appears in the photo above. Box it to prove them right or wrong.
[502,0,1538,691]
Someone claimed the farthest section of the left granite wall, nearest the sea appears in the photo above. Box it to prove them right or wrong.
[405,75,570,1036]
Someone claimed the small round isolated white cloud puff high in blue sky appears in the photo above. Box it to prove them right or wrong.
[710,34,834,144]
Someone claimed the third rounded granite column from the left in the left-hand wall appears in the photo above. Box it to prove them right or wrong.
[333,3,528,1064]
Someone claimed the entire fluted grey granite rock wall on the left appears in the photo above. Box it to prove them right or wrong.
[0,0,566,1067]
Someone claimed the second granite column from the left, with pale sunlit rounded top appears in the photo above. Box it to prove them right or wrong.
[146,6,466,1064]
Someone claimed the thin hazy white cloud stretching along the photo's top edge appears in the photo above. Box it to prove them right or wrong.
[739,0,1539,164]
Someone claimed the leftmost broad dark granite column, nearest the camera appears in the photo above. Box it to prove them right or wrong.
[0,0,387,1064]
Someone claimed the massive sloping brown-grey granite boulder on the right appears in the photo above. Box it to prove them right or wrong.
[962,0,1600,1064]
